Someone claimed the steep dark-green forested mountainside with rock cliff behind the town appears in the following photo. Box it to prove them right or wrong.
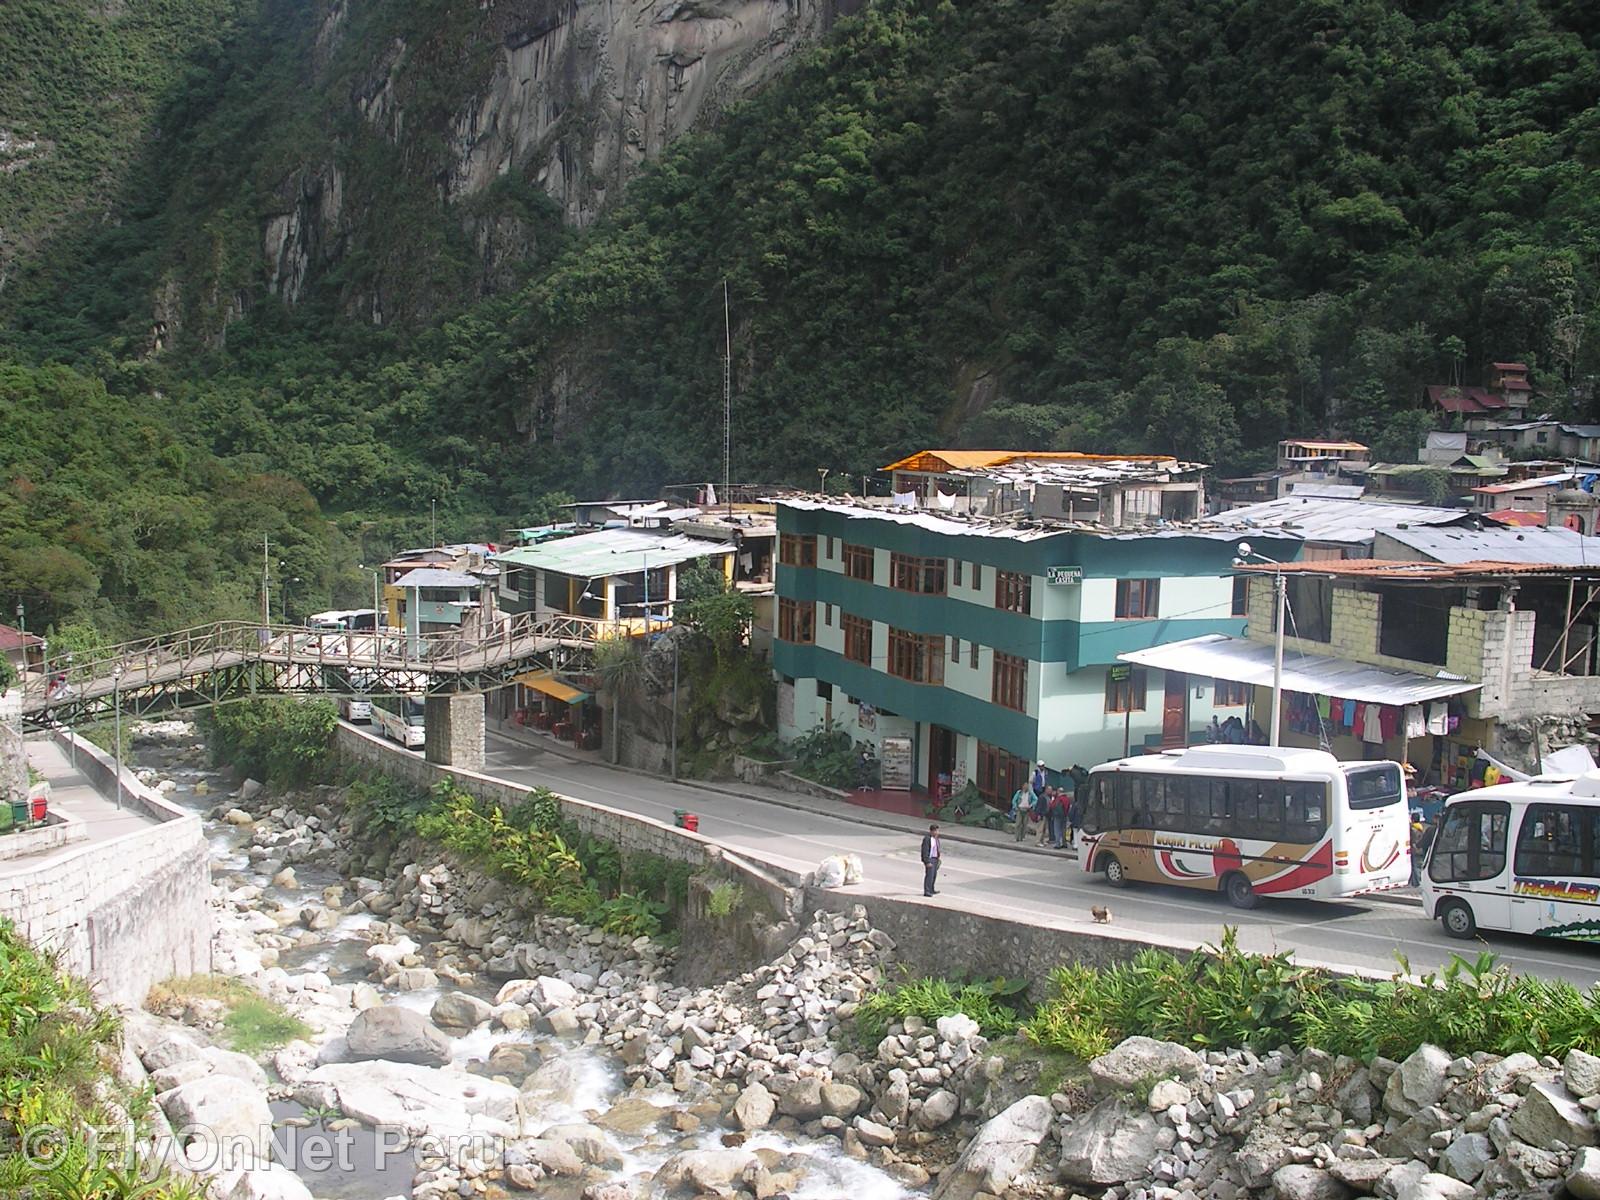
[0,0,1600,640]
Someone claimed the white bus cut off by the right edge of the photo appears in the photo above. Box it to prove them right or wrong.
[1422,771,1600,941]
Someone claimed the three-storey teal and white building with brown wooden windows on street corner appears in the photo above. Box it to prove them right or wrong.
[773,498,1299,800]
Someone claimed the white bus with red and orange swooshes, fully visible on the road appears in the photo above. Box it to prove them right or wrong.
[1078,746,1411,909]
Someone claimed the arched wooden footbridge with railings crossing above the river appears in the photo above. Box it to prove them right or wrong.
[22,613,614,739]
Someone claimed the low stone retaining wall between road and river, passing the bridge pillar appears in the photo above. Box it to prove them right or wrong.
[334,722,808,918]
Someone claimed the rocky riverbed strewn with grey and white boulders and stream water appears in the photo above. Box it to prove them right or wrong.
[116,723,1600,1200]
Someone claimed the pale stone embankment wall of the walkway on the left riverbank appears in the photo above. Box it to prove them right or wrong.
[0,733,211,1005]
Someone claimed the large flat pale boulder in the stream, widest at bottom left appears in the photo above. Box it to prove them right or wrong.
[300,1062,520,1138]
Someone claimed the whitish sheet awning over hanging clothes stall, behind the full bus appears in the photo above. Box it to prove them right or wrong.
[1117,634,1482,704]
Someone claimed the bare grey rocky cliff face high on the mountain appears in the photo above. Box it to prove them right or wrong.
[261,0,862,323]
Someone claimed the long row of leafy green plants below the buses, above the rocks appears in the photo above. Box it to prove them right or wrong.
[1022,928,1600,1059]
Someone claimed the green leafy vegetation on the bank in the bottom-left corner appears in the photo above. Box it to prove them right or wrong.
[0,920,202,1200]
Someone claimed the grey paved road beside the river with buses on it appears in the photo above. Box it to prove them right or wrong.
[485,733,1600,987]
